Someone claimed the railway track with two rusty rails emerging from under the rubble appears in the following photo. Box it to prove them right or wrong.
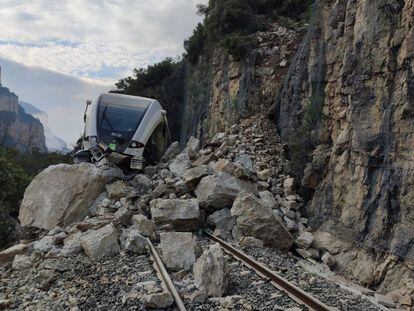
[148,231,386,311]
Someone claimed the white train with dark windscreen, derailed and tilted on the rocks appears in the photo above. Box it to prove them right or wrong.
[75,93,171,170]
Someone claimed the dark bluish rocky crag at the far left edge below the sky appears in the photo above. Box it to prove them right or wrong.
[0,86,47,152]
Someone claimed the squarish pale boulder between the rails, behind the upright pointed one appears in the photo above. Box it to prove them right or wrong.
[160,232,196,271]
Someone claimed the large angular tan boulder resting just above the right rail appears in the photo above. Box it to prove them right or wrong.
[231,192,293,250]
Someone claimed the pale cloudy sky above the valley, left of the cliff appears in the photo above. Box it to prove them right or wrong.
[0,0,207,144]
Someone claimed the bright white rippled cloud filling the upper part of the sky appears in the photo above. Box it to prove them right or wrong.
[0,0,206,81]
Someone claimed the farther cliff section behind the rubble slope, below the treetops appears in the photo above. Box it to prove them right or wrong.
[180,24,302,142]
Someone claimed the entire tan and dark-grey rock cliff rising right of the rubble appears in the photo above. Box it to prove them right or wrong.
[171,0,414,302]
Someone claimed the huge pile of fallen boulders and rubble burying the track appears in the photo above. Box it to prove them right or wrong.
[0,117,335,310]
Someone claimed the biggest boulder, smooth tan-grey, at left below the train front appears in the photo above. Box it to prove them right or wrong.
[19,163,121,229]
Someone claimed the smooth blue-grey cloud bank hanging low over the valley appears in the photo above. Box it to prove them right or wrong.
[0,58,112,145]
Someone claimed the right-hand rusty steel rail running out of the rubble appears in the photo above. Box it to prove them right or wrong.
[203,231,337,311]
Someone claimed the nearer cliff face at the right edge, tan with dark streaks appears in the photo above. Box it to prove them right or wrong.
[278,0,414,296]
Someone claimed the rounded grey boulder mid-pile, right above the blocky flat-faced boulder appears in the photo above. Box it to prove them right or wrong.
[195,172,258,211]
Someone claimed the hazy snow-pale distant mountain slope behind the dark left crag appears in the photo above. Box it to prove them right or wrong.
[19,101,69,153]
